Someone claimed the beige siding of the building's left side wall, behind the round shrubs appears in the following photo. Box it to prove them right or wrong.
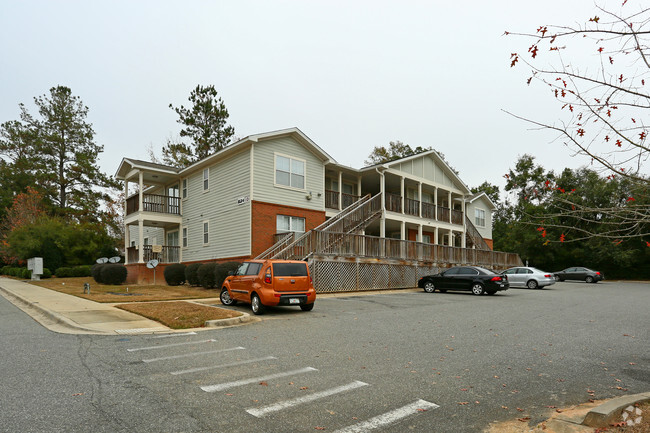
[179,148,251,262]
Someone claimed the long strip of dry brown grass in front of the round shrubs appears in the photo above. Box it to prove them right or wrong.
[30,277,219,303]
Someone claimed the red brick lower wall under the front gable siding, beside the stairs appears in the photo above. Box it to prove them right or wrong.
[251,200,325,257]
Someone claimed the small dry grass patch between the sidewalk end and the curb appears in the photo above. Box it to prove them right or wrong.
[117,301,242,329]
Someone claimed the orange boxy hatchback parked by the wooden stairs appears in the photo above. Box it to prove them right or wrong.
[220,260,316,314]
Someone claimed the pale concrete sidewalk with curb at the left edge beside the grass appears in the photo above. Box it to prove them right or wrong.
[0,277,170,335]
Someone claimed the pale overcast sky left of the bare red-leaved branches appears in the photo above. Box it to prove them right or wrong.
[0,0,636,197]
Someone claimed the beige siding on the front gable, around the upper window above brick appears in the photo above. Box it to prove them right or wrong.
[253,137,325,210]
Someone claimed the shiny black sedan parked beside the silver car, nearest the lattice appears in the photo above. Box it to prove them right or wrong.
[418,266,510,295]
